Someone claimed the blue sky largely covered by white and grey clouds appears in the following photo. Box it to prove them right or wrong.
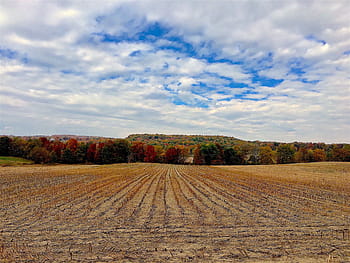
[0,0,350,143]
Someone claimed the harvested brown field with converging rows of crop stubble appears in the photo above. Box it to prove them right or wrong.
[0,163,350,262]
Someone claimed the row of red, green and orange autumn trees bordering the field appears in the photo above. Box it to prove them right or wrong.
[0,136,350,165]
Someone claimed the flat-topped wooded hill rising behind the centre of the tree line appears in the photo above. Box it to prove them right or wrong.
[126,134,247,147]
